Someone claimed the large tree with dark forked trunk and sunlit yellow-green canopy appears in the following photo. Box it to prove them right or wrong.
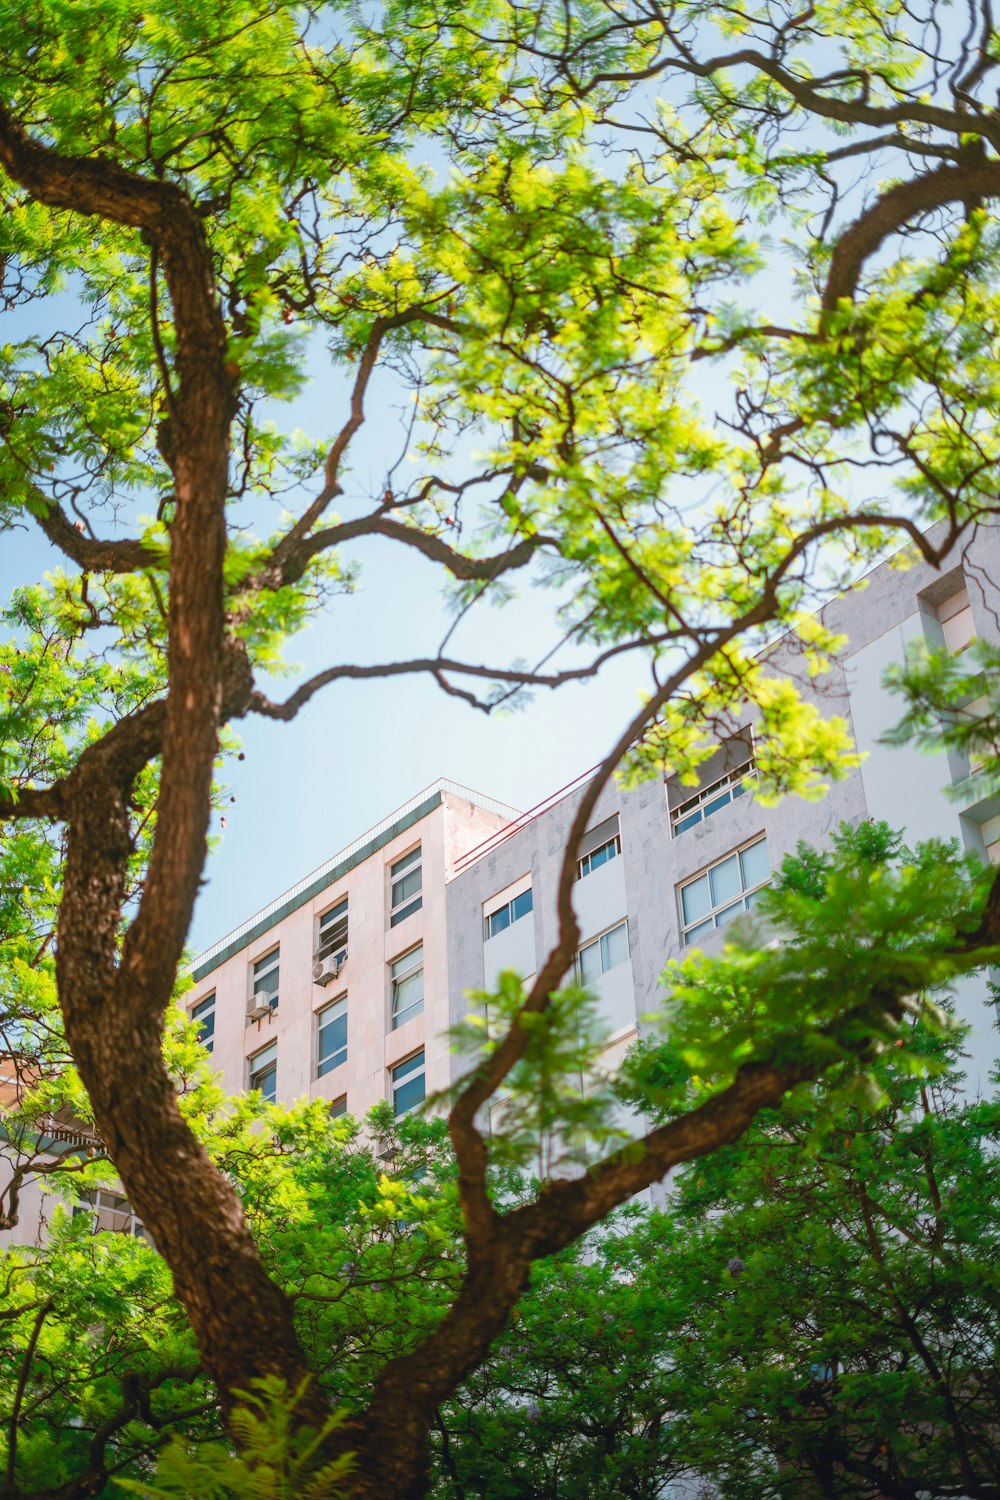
[0,0,1000,1497]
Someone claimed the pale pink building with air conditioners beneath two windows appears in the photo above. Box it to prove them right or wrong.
[187,782,517,1115]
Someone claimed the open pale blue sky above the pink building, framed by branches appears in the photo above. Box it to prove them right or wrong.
[0,339,646,951]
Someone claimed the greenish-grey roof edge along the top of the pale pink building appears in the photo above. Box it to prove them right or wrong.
[189,777,520,981]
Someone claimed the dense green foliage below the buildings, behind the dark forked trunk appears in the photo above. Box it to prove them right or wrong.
[0,825,1000,1500]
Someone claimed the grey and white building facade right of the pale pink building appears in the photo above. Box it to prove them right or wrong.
[447,528,1000,1092]
